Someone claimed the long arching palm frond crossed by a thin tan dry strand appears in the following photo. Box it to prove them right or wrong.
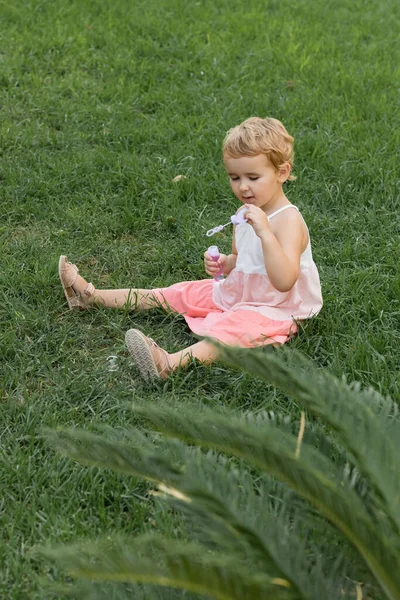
[135,404,400,599]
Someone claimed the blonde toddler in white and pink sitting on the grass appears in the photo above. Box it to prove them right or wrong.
[59,117,322,379]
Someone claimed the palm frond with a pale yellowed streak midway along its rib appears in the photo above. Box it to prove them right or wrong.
[46,429,316,587]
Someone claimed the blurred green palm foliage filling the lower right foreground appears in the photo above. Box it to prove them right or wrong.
[41,349,400,600]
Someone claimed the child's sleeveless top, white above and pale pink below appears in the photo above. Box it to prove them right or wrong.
[213,204,322,321]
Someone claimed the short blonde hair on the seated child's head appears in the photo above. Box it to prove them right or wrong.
[222,117,296,180]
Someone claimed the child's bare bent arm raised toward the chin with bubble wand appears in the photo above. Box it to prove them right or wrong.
[246,206,308,292]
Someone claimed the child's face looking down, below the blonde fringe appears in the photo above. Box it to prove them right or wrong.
[224,154,290,210]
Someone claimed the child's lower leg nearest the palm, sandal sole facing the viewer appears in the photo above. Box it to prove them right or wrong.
[125,329,218,379]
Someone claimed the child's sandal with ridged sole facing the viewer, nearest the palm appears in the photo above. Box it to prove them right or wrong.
[125,329,172,380]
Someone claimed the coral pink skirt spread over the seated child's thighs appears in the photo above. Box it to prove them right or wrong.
[152,279,297,347]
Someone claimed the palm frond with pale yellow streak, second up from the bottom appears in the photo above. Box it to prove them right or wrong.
[43,430,320,597]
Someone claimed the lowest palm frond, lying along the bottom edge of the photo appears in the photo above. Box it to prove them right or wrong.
[41,535,294,600]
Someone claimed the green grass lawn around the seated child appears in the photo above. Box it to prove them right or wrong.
[0,0,400,600]
